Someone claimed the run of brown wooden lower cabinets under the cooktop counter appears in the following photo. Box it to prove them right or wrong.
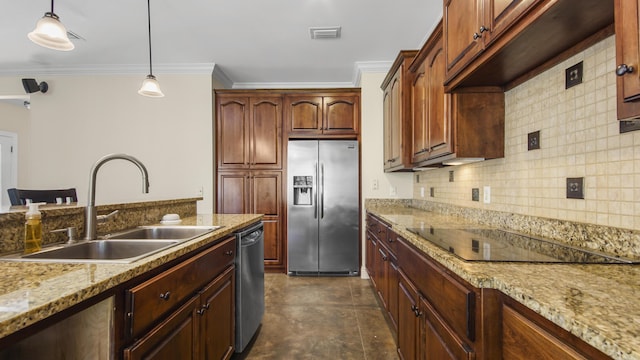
[367,227,608,360]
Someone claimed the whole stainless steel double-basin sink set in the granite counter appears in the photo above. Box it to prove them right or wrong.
[5,225,220,263]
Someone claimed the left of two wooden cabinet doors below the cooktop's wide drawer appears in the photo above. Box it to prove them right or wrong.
[398,270,419,360]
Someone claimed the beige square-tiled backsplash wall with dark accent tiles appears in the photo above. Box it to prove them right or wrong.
[413,36,640,230]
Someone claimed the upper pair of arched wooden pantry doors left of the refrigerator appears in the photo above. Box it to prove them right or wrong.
[216,94,282,169]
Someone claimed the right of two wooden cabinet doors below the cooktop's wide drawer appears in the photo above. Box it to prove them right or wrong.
[420,297,475,360]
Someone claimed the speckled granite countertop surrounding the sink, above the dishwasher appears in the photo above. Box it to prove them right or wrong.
[0,214,262,338]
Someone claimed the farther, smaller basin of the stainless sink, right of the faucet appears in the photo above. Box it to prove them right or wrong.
[102,226,220,240]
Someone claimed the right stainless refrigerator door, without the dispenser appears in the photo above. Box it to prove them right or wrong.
[318,140,359,275]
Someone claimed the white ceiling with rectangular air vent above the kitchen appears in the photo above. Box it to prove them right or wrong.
[0,0,442,88]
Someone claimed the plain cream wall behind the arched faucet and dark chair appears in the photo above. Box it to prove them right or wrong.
[0,74,213,213]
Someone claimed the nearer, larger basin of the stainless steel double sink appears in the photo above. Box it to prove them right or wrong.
[21,240,180,263]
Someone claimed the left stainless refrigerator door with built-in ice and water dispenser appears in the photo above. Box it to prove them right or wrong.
[287,140,319,273]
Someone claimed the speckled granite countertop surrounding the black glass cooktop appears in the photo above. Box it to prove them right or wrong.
[367,205,640,359]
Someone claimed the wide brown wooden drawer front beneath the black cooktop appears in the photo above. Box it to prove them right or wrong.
[397,241,476,342]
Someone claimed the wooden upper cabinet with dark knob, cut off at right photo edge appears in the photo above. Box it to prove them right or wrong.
[612,0,640,120]
